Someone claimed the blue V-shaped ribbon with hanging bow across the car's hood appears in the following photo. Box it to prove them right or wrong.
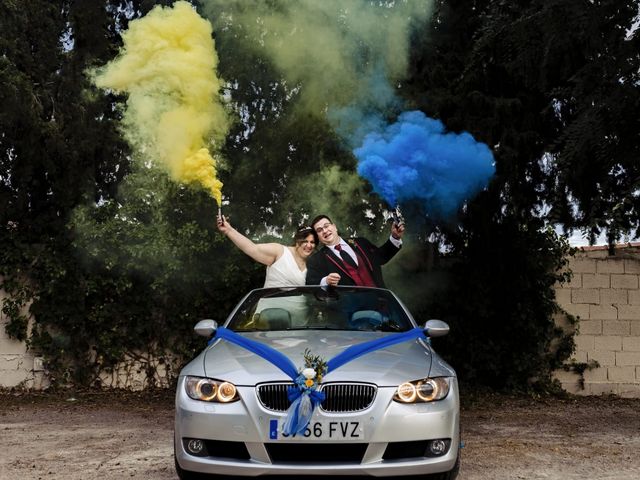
[208,327,428,435]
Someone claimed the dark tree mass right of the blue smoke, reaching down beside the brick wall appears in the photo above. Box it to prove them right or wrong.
[407,0,640,388]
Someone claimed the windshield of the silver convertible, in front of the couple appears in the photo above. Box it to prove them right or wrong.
[228,287,413,332]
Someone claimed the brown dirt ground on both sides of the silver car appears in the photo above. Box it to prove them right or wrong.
[0,392,640,480]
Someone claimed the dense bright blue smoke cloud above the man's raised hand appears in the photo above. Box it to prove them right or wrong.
[353,111,495,220]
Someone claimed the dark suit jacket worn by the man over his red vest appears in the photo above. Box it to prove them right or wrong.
[307,237,400,288]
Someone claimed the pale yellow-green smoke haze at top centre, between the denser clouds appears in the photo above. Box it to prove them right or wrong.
[201,0,435,114]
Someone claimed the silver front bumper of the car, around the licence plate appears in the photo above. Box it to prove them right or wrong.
[174,377,460,477]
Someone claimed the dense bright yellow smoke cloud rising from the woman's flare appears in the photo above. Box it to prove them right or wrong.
[93,1,230,205]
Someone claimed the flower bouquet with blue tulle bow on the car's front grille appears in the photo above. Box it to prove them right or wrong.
[282,349,327,435]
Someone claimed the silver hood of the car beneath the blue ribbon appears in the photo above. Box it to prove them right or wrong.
[196,330,455,386]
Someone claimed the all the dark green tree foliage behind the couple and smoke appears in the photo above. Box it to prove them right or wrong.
[0,0,640,388]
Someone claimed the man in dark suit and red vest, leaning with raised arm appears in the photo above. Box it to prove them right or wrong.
[307,215,404,288]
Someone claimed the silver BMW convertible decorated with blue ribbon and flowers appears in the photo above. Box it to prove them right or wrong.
[174,287,460,480]
